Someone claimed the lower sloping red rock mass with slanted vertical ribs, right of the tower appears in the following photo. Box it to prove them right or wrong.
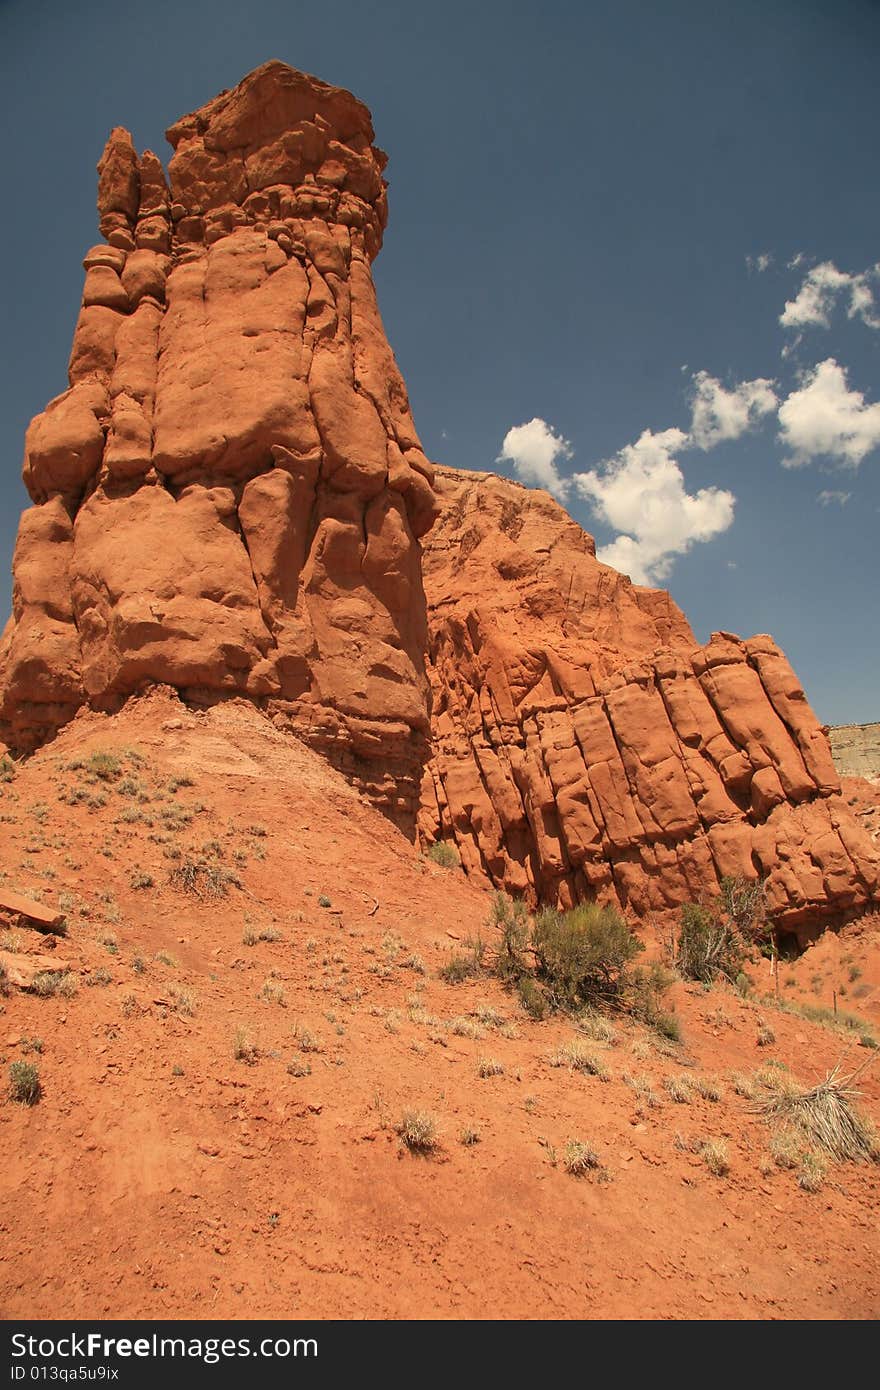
[420,468,880,935]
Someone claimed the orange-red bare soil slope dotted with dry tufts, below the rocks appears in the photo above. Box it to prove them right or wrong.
[0,695,880,1319]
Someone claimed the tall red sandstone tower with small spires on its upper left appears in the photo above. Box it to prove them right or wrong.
[0,63,435,827]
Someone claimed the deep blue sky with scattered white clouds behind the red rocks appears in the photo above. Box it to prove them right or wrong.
[0,0,880,723]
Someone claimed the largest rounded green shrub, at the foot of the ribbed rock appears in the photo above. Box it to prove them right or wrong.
[532,902,644,1009]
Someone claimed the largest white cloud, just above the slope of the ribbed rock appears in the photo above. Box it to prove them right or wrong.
[571,430,735,584]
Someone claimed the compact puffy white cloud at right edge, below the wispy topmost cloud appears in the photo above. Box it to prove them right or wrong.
[779,357,880,468]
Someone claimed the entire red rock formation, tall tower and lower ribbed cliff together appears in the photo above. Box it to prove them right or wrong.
[0,63,877,931]
